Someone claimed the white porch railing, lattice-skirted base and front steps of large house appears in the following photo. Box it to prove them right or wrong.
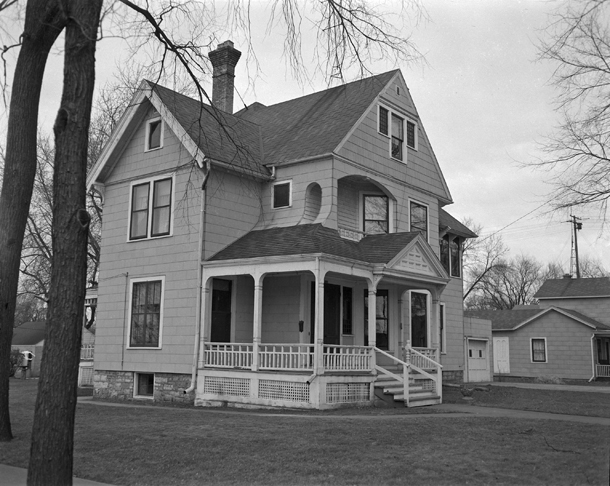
[195,343,442,409]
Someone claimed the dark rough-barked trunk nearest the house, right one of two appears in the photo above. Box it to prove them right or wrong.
[28,0,102,485]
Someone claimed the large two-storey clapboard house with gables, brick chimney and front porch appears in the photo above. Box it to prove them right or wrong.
[88,42,476,408]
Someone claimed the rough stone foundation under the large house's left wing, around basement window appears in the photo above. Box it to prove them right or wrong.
[93,370,195,405]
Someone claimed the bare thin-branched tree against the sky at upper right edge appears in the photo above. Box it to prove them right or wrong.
[534,0,610,220]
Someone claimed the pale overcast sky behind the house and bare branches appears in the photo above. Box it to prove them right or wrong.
[8,0,610,268]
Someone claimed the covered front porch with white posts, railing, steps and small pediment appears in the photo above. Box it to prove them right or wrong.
[195,226,447,408]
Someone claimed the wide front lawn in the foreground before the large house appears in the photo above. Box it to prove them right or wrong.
[0,380,610,485]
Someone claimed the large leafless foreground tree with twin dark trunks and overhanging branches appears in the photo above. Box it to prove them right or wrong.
[0,0,426,484]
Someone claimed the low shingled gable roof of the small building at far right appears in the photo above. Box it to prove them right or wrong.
[464,306,610,331]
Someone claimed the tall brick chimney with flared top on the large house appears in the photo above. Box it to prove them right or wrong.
[208,41,241,113]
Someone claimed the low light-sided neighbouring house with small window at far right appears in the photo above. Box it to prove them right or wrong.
[465,278,610,380]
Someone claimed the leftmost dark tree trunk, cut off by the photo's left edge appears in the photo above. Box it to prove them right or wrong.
[0,0,65,441]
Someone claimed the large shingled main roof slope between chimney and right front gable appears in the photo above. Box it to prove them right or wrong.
[236,70,399,165]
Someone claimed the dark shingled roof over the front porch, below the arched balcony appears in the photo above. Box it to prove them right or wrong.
[209,224,419,264]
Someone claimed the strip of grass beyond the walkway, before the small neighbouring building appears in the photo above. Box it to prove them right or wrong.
[443,386,610,418]
